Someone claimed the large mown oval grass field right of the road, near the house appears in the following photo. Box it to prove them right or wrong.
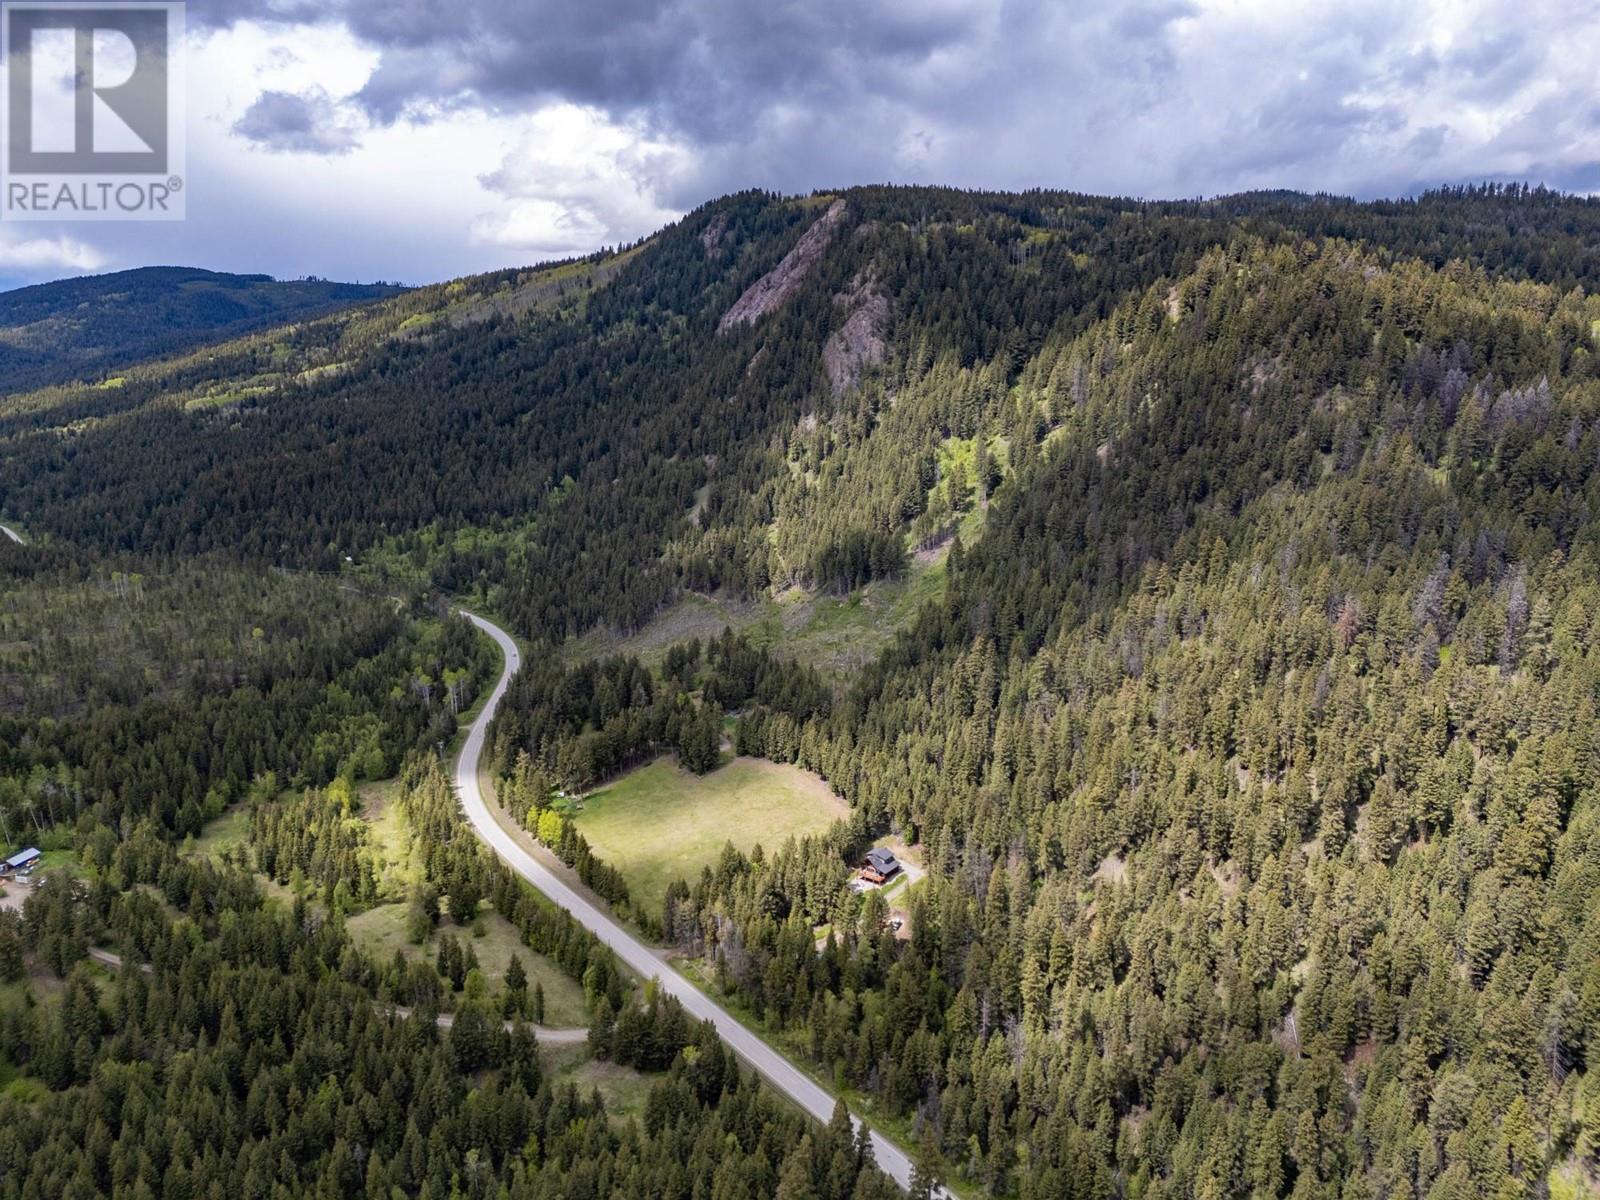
[573,758,848,912]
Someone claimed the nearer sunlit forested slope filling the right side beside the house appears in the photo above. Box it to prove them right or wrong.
[499,230,1600,1197]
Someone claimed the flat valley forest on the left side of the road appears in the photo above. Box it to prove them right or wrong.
[0,566,896,1200]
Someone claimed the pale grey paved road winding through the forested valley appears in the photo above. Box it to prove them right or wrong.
[456,613,949,1197]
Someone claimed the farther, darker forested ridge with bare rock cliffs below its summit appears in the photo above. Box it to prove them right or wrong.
[9,189,1600,635]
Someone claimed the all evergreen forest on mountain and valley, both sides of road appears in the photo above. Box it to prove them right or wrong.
[9,186,1600,1200]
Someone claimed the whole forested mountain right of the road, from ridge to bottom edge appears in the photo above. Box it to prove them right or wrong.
[9,189,1600,1200]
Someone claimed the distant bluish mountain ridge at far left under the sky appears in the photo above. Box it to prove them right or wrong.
[0,267,403,392]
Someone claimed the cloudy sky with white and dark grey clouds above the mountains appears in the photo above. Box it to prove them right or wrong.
[0,0,1600,285]
